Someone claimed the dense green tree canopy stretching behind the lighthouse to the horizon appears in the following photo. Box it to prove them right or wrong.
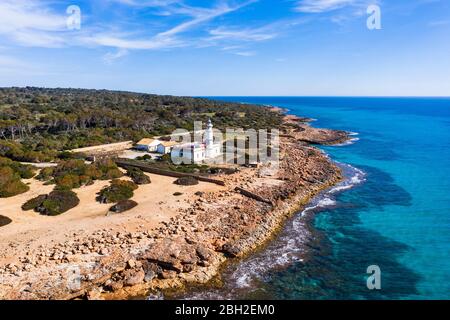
[0,87,281,162]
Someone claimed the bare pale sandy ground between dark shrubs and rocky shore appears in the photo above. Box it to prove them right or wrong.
[0,174,223,265]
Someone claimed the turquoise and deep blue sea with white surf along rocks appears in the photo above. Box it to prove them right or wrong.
[173,97,450,299]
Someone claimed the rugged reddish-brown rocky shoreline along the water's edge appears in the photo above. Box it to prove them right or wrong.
[0,112,349,299]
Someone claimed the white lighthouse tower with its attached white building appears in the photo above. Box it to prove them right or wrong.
[171,119,221,164]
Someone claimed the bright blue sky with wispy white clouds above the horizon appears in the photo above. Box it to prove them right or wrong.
[0,0,450,96]
